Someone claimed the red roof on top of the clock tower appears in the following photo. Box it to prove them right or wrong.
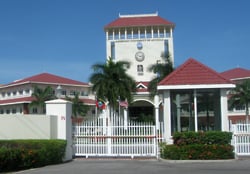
[104,16,175,29]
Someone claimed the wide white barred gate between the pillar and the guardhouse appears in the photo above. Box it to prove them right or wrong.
[73,115,162,158]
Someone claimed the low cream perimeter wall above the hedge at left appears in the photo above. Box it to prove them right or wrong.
[0,114,57,139]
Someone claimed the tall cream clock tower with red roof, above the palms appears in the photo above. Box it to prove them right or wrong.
[104,13,175,82]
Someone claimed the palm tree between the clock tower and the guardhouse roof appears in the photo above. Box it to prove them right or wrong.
[148,53,174,97]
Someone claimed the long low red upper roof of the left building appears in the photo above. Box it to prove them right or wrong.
[8,73,88,86]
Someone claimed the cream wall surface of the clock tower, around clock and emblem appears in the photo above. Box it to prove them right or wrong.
[106,38,174,81]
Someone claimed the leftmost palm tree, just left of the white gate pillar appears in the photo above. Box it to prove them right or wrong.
[29,86,56,113]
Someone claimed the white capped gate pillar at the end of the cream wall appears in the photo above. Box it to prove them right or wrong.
[45,99,73,161]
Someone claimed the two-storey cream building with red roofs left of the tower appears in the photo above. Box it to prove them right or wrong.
[0,73,95,115]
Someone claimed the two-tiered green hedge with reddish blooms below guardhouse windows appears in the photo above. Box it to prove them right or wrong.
[161,131,234,160]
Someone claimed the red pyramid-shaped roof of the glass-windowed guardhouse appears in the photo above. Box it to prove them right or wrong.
[159,58,232,85]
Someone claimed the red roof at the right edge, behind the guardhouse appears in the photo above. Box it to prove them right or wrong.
[220,68,250,80]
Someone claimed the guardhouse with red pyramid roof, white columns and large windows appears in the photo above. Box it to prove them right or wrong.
[157,58,235,143]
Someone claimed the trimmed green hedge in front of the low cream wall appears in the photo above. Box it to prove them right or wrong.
[0,140,66,172]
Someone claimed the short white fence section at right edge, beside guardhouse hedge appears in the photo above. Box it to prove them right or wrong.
[232,123,250,156]
